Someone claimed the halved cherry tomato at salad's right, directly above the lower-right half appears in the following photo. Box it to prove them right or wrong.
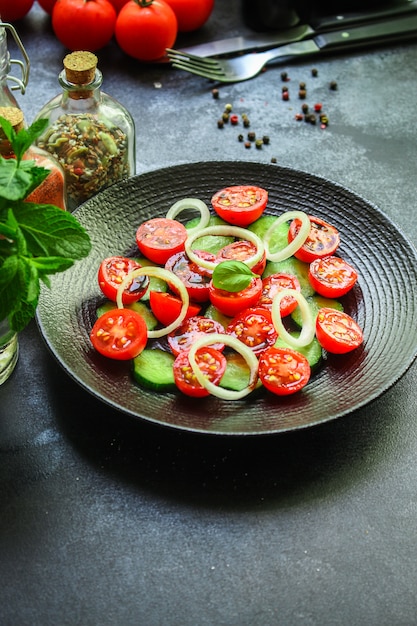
[308,256,358,298]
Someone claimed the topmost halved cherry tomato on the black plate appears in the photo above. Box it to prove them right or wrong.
[211,185,268,226]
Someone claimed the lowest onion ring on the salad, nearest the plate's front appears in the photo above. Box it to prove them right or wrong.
[188,333,258,400]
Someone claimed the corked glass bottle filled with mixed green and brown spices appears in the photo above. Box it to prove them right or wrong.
[35,51,136,211]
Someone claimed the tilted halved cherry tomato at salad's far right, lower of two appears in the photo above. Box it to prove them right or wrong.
[316,307,363,354]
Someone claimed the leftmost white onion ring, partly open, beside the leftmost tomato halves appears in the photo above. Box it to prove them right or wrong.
[116,265,190,339]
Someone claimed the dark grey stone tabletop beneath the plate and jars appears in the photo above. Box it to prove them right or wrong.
[0,0,417,626]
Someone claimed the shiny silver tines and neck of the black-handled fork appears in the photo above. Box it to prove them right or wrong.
[166,40,318,83]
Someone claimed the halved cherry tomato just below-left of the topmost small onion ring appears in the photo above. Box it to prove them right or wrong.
[136,217,188,265]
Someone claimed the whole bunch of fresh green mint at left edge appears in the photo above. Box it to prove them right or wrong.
[0,117,91,332]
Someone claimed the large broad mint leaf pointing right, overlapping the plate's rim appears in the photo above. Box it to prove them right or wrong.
[14,202,91,260]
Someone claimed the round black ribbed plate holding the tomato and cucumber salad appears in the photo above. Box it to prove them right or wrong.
[37,162,417,435]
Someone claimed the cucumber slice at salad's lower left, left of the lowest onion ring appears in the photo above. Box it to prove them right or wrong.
[133,348,176,391]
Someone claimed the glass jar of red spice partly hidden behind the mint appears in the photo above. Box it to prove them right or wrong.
[0,106,66,211]
